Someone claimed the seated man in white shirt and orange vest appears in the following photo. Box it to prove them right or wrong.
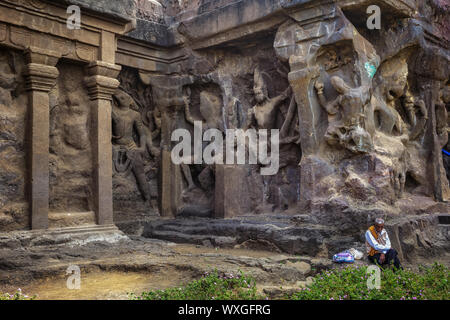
[366,218,403,269]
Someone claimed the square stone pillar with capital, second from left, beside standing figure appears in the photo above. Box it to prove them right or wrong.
[85,61,121,225]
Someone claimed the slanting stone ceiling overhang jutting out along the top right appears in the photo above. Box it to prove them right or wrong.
[178,0,415,49]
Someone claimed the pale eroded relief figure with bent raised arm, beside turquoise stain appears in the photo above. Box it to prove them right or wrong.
[315,76,373,153]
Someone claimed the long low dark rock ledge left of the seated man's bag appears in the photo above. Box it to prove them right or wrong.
[142,216,354,256]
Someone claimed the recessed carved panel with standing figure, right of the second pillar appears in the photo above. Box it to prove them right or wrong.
[112,68,161,221]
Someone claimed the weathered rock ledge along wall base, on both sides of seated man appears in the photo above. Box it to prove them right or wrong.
[140,214,450,262]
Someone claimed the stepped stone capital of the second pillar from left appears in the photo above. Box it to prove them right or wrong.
[84,61,122,100]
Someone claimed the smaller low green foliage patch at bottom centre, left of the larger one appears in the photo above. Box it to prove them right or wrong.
[130,270,265,300]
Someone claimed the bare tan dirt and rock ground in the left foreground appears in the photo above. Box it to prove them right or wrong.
[0,238,450,300]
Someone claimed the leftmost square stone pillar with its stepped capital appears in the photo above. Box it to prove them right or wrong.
[24,48,59,229]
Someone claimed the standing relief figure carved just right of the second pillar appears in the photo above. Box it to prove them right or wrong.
[112,91,151,203]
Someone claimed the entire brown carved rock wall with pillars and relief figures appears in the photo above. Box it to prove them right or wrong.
[0,0,450,230]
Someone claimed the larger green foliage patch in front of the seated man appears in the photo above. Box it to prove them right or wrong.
[288,263,450,300]
